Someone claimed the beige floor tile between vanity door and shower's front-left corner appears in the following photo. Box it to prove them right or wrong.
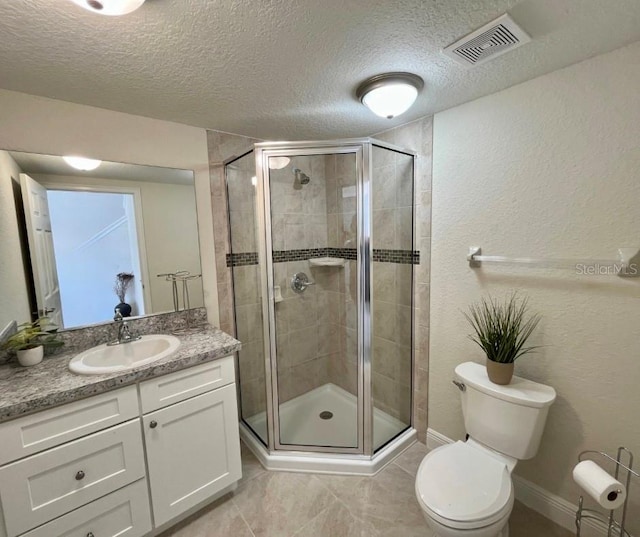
[233,472,336,537]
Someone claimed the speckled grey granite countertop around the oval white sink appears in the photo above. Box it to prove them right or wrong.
[0,327,241,422]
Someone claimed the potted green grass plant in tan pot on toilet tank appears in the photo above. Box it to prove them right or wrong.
[464,293,540,385]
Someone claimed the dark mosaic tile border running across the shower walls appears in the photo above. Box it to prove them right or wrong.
[227,248,420,267]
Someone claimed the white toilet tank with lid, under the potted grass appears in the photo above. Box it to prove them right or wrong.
[455,362,556,460]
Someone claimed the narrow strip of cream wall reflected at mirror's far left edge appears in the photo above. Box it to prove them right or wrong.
[0,151,31,330]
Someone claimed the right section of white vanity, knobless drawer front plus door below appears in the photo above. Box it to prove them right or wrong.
[140,357,242,526]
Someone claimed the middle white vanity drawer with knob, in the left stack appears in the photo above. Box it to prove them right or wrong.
[0,419,145,537]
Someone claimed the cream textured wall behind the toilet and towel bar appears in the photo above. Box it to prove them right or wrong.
[429,43,640,531]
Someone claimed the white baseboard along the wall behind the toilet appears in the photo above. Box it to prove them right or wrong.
[427,429,607,537]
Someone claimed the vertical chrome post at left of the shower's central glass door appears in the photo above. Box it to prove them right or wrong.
[256,144,279,451]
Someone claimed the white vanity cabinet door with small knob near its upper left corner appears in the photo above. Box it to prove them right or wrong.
[143,384,242,527]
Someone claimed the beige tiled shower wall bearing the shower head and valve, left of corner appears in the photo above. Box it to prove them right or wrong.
[270,155,335,403]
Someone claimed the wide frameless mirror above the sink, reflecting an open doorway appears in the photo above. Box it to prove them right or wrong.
[0,150,204,330]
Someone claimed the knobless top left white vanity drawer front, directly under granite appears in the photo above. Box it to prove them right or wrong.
[0,386,140,465]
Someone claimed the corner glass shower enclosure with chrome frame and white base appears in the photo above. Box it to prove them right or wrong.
[225,139,419,473]
